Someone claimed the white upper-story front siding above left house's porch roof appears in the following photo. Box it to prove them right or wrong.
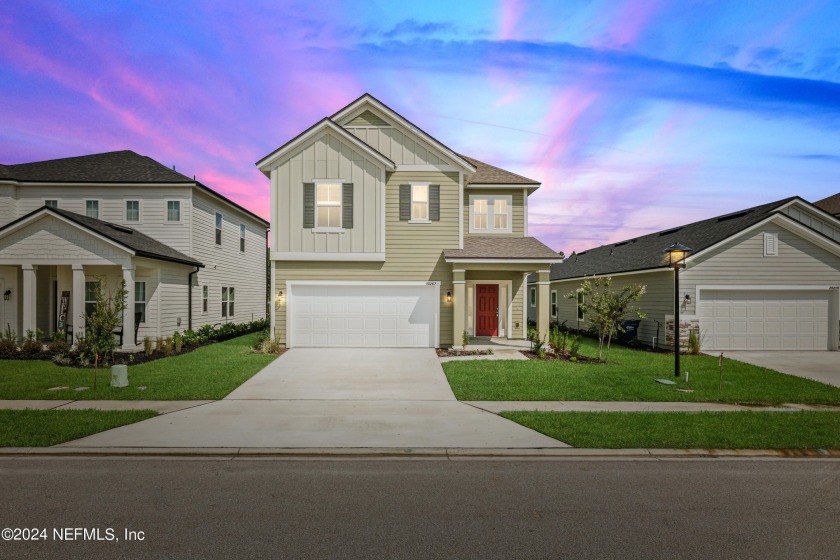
[0,185,191,255]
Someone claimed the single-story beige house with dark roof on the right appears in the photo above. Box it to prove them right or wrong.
[529,197,840,351]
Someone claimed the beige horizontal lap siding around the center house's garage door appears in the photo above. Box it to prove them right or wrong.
[272,172,458,345]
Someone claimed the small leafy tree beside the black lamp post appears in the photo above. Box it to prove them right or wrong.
[566,276,647,363]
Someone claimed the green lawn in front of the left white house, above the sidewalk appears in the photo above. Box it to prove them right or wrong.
[0,333,276,400]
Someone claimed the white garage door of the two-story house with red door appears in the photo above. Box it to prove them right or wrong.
[288,283,439,348]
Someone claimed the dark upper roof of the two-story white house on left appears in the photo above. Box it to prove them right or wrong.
[0,150,268,226]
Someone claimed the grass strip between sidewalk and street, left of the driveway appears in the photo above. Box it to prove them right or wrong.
[0,410,157,447]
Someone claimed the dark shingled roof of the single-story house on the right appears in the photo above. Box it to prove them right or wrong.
[551,196,836,280]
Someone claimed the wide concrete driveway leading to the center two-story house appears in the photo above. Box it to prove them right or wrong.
[62,348,568,449]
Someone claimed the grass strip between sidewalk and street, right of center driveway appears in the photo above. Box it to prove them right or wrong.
[501,411,840,449]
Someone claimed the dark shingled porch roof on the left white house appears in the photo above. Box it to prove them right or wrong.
[0,206,204,267]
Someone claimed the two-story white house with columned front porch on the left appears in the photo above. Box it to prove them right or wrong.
[0,150,268,350]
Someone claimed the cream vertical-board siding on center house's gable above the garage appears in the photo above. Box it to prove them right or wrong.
[271,133,384,254]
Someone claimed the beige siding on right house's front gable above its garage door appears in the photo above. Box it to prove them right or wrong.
[680,224,840,315]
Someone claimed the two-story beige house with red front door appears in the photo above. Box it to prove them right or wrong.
[257,94,560,347]
